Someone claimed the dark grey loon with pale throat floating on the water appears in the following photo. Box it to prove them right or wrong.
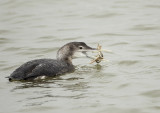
[7,42,96,81]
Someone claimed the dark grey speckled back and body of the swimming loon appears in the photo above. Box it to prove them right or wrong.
[9,59,74,80]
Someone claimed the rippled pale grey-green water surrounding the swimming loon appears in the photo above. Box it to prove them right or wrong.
[0,0,160,113]
